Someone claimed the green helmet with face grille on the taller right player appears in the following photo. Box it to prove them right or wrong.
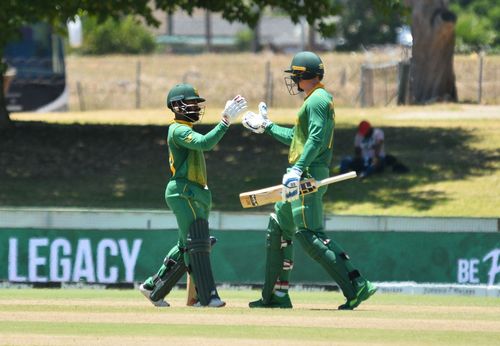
[285,51,325,95]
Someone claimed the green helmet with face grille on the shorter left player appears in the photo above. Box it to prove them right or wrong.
[167,83,205,122]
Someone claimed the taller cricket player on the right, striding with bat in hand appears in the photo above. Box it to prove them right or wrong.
[243,51,377,310]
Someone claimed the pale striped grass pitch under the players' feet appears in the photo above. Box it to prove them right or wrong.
[0,289,500,345]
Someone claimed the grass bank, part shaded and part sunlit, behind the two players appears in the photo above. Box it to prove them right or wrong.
[0,104,500,217]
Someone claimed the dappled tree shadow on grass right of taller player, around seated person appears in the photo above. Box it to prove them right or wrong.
[326,123,500,211]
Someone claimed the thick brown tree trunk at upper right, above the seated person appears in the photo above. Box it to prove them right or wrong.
[407,0,458,104]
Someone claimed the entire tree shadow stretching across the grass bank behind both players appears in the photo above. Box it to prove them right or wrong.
[0,122,500,211]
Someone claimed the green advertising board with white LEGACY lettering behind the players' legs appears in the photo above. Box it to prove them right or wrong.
[0,228,500,285]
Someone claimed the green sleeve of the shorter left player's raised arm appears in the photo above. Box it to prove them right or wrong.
[173,123,228,151]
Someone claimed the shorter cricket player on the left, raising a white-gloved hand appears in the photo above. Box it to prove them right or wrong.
[139,84,247,307]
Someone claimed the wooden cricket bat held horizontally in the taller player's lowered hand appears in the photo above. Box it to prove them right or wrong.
[240,171,356,208]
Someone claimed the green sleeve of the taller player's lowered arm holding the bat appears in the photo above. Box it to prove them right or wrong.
[295,99,333,170]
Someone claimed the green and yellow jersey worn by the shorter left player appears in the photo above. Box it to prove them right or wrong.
[167,120,228,186]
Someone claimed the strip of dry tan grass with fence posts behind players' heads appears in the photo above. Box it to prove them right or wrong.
[67,53,500,110]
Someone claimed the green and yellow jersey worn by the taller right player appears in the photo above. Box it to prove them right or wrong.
[266,83,335,171]
